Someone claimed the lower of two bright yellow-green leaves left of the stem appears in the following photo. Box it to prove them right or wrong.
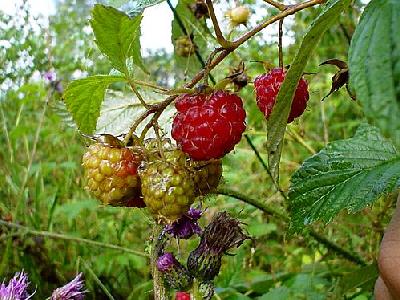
[64,75,124,134]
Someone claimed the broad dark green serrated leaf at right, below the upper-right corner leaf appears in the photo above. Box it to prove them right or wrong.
[289,124,400,231]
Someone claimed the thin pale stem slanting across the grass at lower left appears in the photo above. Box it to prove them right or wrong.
[0,220,148,257]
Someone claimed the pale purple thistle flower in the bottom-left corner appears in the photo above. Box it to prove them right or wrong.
[0,271,32,300]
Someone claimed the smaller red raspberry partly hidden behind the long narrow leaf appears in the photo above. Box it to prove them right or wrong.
[254,68,309,123]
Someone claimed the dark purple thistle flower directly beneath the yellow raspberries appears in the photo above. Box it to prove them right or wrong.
[165,208,203,239]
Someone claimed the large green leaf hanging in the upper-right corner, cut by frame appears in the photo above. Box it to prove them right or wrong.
[349,0,400,146]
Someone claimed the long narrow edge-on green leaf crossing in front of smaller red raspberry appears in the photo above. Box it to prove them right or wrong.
[267,0,350,181]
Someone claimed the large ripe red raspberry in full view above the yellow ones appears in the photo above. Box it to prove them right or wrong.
[172,91,246,160]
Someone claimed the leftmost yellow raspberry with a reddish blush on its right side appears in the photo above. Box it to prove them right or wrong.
[82,143,143,207]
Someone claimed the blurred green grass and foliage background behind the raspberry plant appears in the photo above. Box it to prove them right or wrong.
[0,0,394,300]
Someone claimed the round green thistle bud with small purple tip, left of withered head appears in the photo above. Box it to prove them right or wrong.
[157,252,193,290]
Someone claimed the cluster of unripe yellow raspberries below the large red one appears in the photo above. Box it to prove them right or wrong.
[82,139,222,224]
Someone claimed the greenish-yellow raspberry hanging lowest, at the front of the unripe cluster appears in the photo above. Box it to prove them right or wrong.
[139,160,195,223]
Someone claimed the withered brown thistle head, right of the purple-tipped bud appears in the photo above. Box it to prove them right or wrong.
[187,212,249,281]
